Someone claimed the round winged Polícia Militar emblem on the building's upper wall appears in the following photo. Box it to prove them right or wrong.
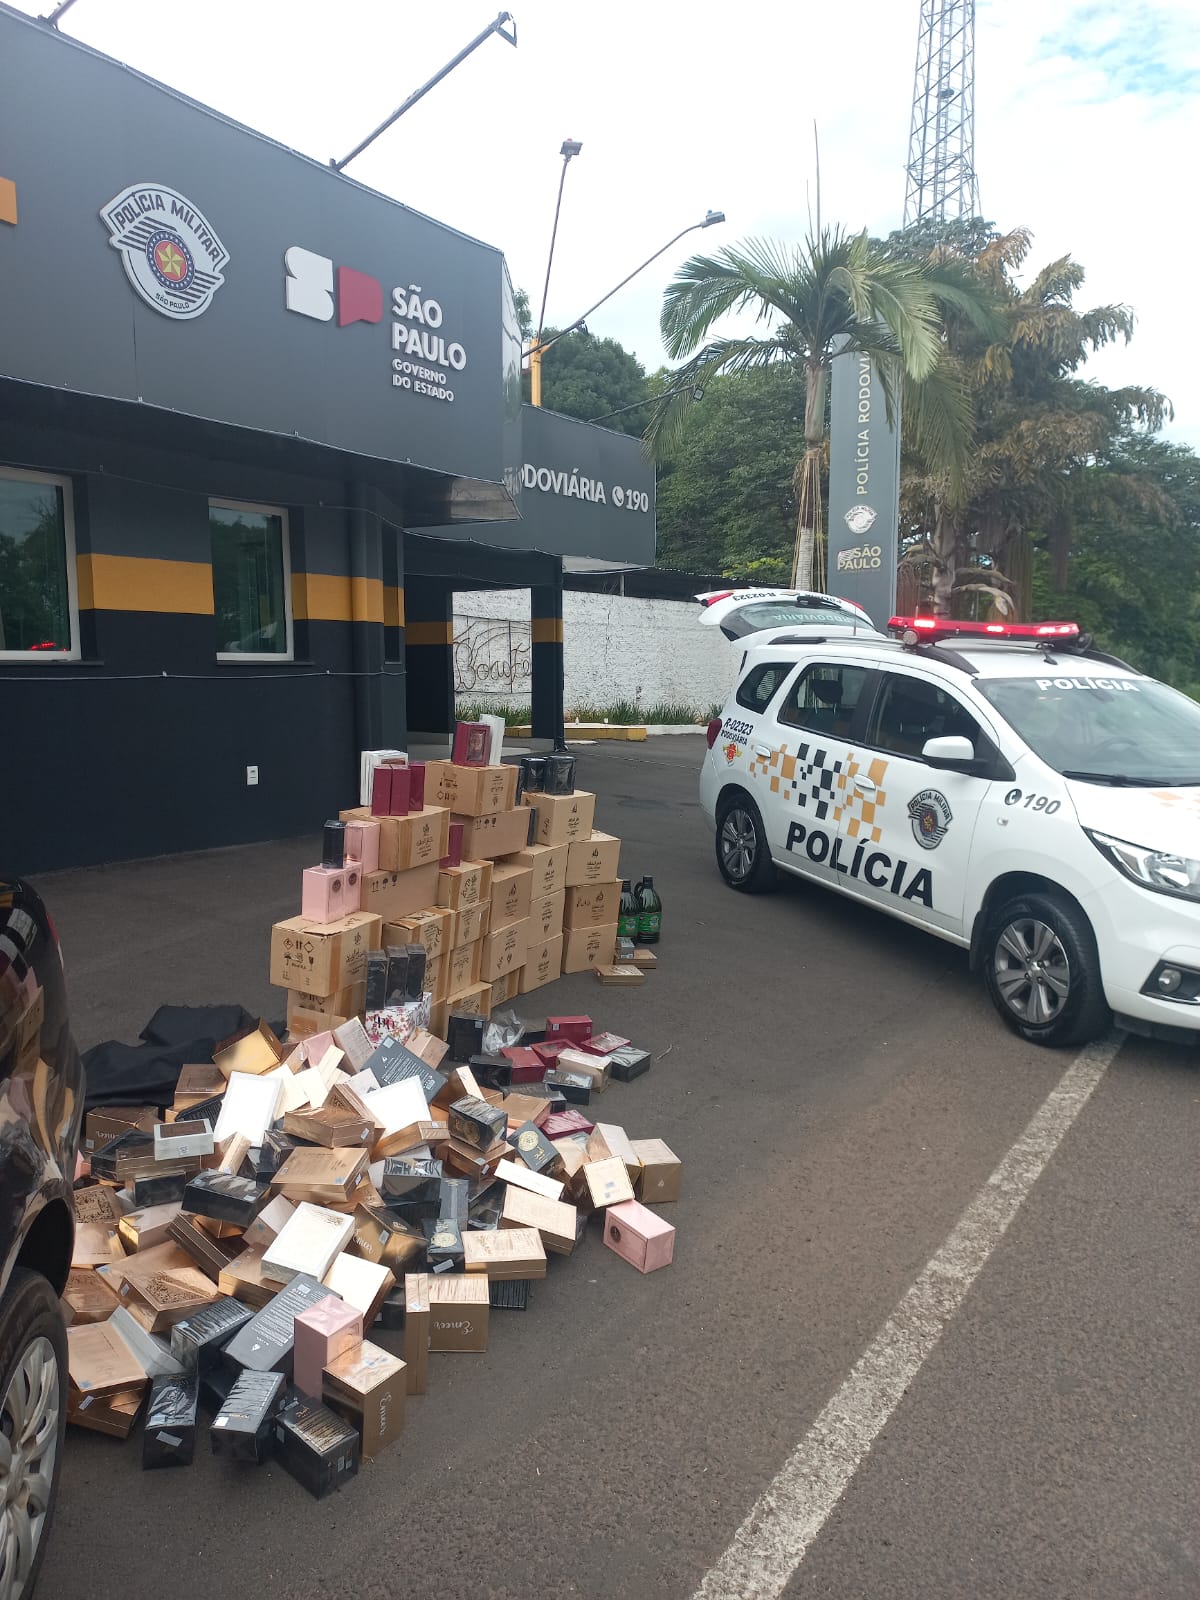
[101,184,229,320]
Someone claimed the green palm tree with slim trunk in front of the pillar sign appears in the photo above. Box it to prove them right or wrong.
[645,226,989,589]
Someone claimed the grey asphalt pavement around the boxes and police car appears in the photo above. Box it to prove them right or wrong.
[32,736,1200,1600]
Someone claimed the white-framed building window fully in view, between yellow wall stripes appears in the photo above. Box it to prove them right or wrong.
[208,501,291,661]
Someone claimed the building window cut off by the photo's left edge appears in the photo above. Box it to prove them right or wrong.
[0,467,78,661]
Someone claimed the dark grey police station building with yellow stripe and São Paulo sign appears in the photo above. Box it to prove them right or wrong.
[0,5,654,872]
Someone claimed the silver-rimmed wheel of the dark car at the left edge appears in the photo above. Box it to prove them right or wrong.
[0,1267,67,1600]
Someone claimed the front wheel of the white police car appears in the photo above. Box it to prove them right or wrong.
[984,894,1112,1045]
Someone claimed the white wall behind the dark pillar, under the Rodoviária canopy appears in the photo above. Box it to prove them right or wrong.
[454,589,741,717]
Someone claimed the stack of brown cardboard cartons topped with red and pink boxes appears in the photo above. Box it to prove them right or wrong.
[270,762,656,1042]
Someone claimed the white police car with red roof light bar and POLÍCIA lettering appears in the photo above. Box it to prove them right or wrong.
[701,618,1200,1045]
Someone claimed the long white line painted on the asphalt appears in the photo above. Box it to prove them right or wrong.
[693,1035,1123,1600]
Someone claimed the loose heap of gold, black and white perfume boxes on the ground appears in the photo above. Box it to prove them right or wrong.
[64,1011,682,1496]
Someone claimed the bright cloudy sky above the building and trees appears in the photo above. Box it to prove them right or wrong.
[18,0,1200,446]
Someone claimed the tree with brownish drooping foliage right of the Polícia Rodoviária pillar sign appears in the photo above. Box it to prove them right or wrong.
[901,229,1171,616]
